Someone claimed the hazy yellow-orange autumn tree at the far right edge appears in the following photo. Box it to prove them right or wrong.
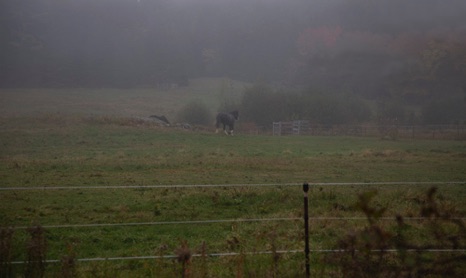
[392,31,466,100]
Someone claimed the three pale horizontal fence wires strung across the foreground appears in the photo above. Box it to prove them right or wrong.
[0,181,466,264]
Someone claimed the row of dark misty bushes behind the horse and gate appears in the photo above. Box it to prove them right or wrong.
[178,83,466,127]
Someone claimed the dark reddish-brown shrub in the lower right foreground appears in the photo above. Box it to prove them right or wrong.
[327,187,466,277]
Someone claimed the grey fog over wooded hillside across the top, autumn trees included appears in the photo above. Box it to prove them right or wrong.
[0,0,466,124]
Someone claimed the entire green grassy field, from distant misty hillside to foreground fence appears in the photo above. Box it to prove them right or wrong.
[0,83,466,277]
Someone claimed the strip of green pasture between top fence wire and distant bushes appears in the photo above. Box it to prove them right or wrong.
[0,114,466,187]
